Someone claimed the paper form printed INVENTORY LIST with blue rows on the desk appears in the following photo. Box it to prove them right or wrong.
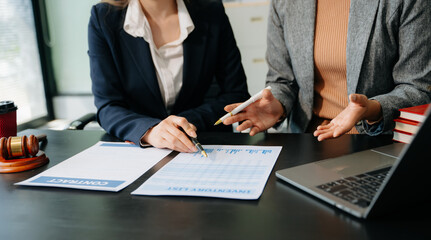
[132,145,281,200]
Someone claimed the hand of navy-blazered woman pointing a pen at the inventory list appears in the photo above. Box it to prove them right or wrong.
[142,115,197,152]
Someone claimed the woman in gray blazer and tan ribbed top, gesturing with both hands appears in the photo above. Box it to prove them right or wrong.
[224,0,431,140]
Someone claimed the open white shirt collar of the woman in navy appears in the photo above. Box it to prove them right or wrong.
[123,0,195,46]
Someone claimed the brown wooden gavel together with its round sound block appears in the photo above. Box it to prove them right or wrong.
[0,135,49,173]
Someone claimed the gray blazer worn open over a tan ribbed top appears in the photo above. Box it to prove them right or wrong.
[266,0,431,135]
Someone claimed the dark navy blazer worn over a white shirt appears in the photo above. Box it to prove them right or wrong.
[88,0,249,144]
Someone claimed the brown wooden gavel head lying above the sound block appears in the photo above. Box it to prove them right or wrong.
[0,135,39,159]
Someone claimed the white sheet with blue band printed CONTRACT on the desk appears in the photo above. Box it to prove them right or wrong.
[16,142,171,192]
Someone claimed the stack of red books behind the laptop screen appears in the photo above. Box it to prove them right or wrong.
[393,103,430,143]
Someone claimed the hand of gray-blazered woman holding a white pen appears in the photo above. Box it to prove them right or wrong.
[223,89,284,136]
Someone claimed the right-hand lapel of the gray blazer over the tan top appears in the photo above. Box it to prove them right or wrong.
[346,0,379,94]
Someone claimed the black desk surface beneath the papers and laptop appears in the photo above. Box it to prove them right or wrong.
[0,130,431,239]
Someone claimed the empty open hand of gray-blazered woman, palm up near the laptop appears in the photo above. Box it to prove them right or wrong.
[314,94,382,141]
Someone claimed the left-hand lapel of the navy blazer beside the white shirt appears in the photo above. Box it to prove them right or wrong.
[120,30,164,106]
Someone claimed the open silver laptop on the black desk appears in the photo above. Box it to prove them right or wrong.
[275,110,431,218]
